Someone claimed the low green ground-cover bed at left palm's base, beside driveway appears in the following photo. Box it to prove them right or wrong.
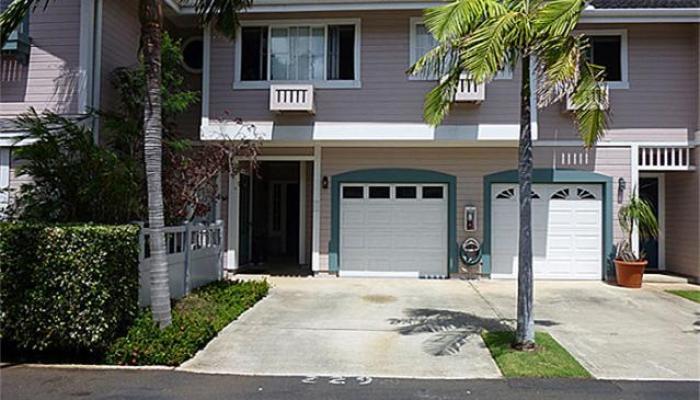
[106,281,269,366]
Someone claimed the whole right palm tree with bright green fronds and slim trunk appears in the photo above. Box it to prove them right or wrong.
[408,0,608,350]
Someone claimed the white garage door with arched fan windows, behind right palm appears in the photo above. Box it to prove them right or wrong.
[491,184,603,279]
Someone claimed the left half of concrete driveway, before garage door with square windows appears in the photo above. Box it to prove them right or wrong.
[182,278,500,378]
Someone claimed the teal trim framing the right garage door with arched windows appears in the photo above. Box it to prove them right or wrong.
[482,168,614,279]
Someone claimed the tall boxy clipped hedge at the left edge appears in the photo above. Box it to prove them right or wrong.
[0,222,139,354]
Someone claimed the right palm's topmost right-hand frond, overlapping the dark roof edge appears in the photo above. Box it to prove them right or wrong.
[534,0,586,37]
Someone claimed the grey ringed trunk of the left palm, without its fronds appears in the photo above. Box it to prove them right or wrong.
[140,0,172,328]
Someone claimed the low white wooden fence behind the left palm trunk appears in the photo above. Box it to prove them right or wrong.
[139,221,223,307]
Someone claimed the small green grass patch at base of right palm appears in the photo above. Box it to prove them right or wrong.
[482,331,591,378]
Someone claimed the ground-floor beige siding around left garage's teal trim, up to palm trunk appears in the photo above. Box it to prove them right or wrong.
[321,148,517,271]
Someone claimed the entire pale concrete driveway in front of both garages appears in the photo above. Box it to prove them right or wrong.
[181,278,700,379]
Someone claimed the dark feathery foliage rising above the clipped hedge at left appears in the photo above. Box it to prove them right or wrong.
[9,108,143,224]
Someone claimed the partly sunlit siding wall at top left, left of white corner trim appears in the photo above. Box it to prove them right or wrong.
[0,0,80,117]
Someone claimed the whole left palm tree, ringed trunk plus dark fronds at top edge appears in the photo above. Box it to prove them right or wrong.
[0,0,252,328]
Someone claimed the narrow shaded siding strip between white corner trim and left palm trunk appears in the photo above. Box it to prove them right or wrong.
[100,0,141,110]
